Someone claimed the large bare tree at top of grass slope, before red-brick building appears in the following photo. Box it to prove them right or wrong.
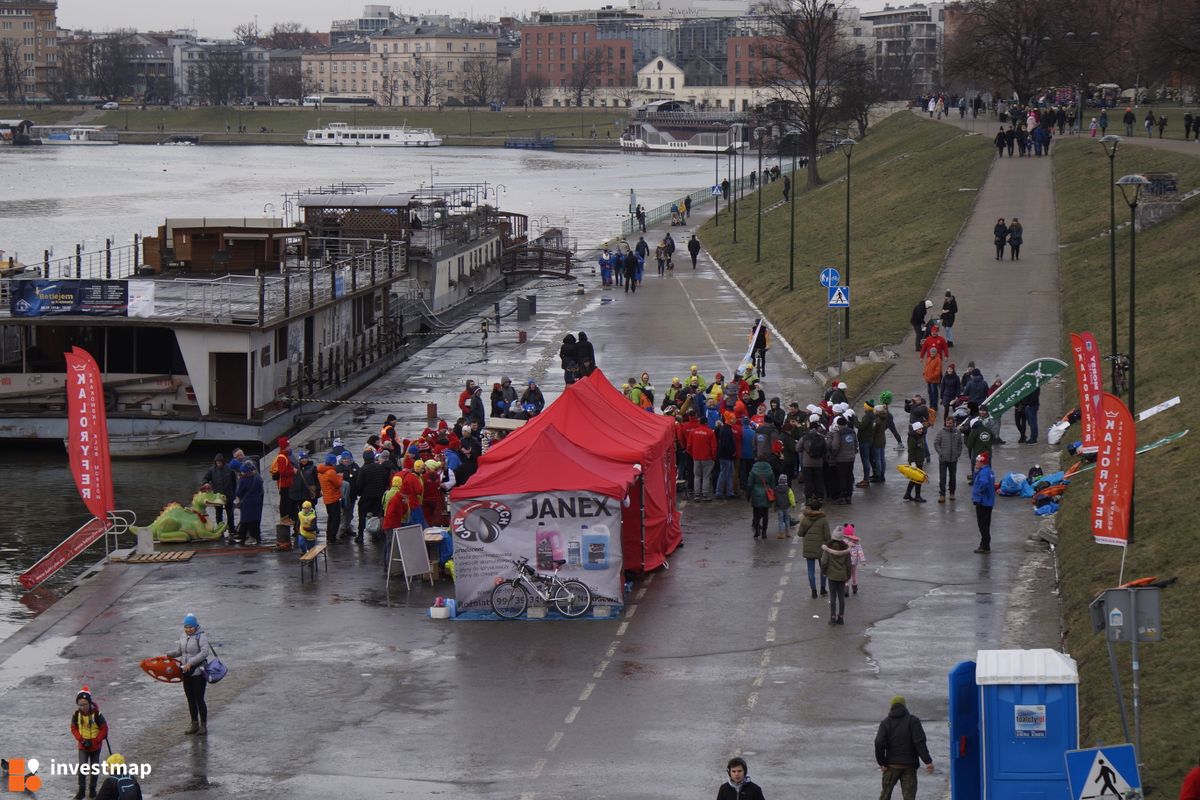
[760,0,862,187]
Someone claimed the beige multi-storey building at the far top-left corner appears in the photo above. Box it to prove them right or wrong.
[0,0,59,102]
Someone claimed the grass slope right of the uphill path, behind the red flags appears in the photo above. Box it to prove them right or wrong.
[1054,137,1200,798]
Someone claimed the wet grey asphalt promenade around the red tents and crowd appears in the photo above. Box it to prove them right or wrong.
[0,148,1057,800]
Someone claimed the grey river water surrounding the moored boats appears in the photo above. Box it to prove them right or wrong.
[0,145,713,640]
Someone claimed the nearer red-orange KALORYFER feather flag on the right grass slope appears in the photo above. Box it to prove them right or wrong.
[1091,392,1138,547]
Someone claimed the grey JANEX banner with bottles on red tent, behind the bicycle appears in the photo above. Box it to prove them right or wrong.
[450,491,624,613]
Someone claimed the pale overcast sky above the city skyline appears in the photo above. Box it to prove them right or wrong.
[59,0,900,37]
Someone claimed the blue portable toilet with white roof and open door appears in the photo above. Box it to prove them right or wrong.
[949,650,1079,800]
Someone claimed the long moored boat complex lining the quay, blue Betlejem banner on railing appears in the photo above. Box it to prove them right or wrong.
[0,184,528,443]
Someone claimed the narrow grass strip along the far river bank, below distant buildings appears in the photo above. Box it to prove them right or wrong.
[0,106,628,139]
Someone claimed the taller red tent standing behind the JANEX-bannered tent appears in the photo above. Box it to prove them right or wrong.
[480,369,683,571]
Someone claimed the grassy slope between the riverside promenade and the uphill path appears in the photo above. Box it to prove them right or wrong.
[700,114,992,367]
